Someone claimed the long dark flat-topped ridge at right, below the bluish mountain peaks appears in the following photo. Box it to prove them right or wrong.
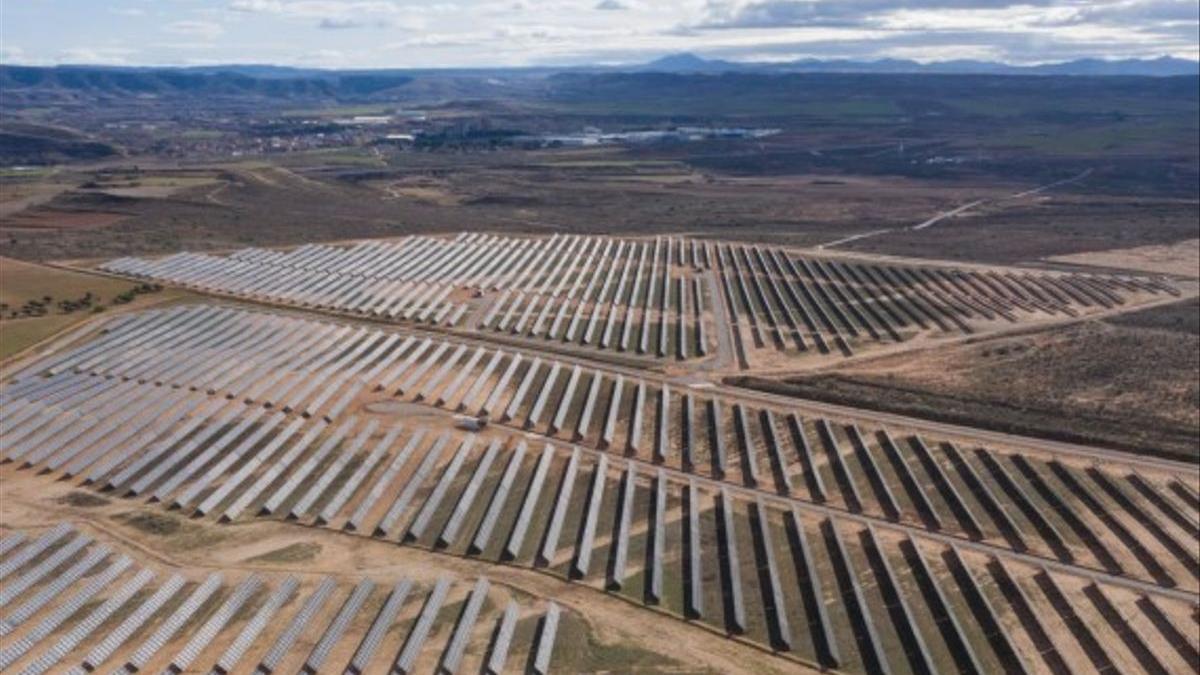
[546,71,1200,117]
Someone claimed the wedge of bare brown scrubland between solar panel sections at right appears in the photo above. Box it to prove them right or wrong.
[737,305,1200,461]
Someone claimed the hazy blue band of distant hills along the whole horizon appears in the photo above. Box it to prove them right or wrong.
[0,54,1200,108]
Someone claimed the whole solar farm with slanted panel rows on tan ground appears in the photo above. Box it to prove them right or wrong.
[0,229,1200,674]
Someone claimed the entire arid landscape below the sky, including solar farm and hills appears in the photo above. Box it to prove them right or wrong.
[0,67,1200,675]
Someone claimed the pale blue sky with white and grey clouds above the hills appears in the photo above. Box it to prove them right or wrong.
[0,0,1200,68]
